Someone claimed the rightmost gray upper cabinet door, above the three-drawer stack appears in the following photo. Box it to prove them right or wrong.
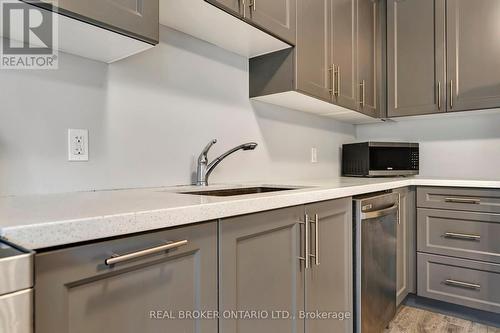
[446,0,500,111]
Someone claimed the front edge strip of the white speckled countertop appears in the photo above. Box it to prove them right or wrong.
[0,178,500,250]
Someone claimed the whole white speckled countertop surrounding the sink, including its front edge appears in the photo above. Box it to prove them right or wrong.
[0,177,500,250]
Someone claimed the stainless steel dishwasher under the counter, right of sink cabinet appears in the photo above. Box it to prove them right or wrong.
[353,193,399,333]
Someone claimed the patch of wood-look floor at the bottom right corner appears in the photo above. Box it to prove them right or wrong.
[384,306,500,333]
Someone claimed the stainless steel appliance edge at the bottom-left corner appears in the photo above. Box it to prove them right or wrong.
[0,240,33,333]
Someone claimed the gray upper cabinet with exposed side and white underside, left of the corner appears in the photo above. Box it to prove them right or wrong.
[249,0,385,123]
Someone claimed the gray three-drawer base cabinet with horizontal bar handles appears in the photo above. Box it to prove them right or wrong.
[417,186,500,313]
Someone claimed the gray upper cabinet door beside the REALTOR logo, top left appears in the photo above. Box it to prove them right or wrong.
[42,0,159,44]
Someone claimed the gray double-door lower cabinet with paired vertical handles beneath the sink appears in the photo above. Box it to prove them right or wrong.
[219,198,352,333]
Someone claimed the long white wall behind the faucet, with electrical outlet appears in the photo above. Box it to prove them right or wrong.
[0,28,355,195]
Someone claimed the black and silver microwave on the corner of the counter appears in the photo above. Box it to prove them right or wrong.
[342,142,419,177]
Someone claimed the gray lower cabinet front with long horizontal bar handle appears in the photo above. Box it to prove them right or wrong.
[35,222,217,333]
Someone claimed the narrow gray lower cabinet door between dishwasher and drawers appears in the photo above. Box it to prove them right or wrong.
[394,187,417,306]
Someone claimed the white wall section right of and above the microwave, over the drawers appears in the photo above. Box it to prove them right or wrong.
[356,110,500,179]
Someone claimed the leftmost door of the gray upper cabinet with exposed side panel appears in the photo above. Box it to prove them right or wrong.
[295,0,333,101]
